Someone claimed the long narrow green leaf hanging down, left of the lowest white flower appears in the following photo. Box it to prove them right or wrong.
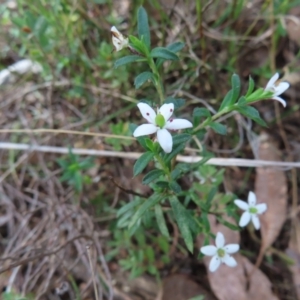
[170,196,194,253]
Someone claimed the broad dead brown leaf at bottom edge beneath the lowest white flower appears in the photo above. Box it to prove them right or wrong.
[199,217,278,300]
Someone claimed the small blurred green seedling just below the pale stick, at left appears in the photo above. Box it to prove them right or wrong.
[57,148,94,193]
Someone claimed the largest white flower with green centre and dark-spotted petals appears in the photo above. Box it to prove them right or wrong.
[133,102,193,153]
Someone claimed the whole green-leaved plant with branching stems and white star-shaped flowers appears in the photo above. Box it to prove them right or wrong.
[111,7,289,271]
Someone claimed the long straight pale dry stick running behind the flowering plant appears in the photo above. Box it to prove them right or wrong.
[0,142,300,168]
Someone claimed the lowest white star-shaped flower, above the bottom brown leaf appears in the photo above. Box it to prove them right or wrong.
[200,232,240,272]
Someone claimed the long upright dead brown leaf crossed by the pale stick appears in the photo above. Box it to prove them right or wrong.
[255,134,287,253]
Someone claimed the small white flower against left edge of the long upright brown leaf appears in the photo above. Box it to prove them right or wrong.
[234,191,267,229]
